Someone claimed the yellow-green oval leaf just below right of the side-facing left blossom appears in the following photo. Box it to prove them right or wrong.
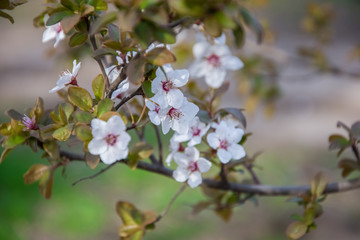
[68,86,93,111]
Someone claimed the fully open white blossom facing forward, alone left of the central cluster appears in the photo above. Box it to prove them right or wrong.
[88,115,131,164]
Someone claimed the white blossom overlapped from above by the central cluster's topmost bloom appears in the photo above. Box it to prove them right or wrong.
[160,97,199,134]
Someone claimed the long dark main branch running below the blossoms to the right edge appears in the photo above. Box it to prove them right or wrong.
[61,152,360,196]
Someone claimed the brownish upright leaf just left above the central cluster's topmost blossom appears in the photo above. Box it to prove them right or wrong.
[126,55,147,85]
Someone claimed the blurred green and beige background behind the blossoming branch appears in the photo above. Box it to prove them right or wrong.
[0,0,360,240]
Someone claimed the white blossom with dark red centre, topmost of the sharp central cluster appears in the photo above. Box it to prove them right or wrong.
[151,65,189,108]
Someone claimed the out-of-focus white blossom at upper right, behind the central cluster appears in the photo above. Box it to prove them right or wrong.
[190,37,244,88]
